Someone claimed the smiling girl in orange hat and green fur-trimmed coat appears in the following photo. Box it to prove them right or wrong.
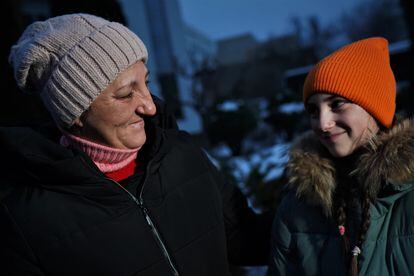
[269,37,414,276]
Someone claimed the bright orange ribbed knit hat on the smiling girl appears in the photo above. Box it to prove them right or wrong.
[303,37,396,127]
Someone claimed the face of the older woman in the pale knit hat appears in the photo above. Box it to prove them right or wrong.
[75,61,156,149]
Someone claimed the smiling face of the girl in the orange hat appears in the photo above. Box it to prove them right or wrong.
[306,93,379,157]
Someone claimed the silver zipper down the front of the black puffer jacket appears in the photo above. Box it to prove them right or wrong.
[107,164,180,276]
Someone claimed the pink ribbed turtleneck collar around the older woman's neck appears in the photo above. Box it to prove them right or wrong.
[60,133,141,173]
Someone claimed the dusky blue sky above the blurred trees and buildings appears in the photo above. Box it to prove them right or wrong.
[179,0,368,40]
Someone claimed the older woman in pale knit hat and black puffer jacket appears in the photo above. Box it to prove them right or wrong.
[0,14,271,275]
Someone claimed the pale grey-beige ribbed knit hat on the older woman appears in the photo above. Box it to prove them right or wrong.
[9,14,148,128]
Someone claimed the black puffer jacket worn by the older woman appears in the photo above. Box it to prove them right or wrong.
[0,102,271,276]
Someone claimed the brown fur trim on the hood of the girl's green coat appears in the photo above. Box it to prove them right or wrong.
[287,119,414,216]
